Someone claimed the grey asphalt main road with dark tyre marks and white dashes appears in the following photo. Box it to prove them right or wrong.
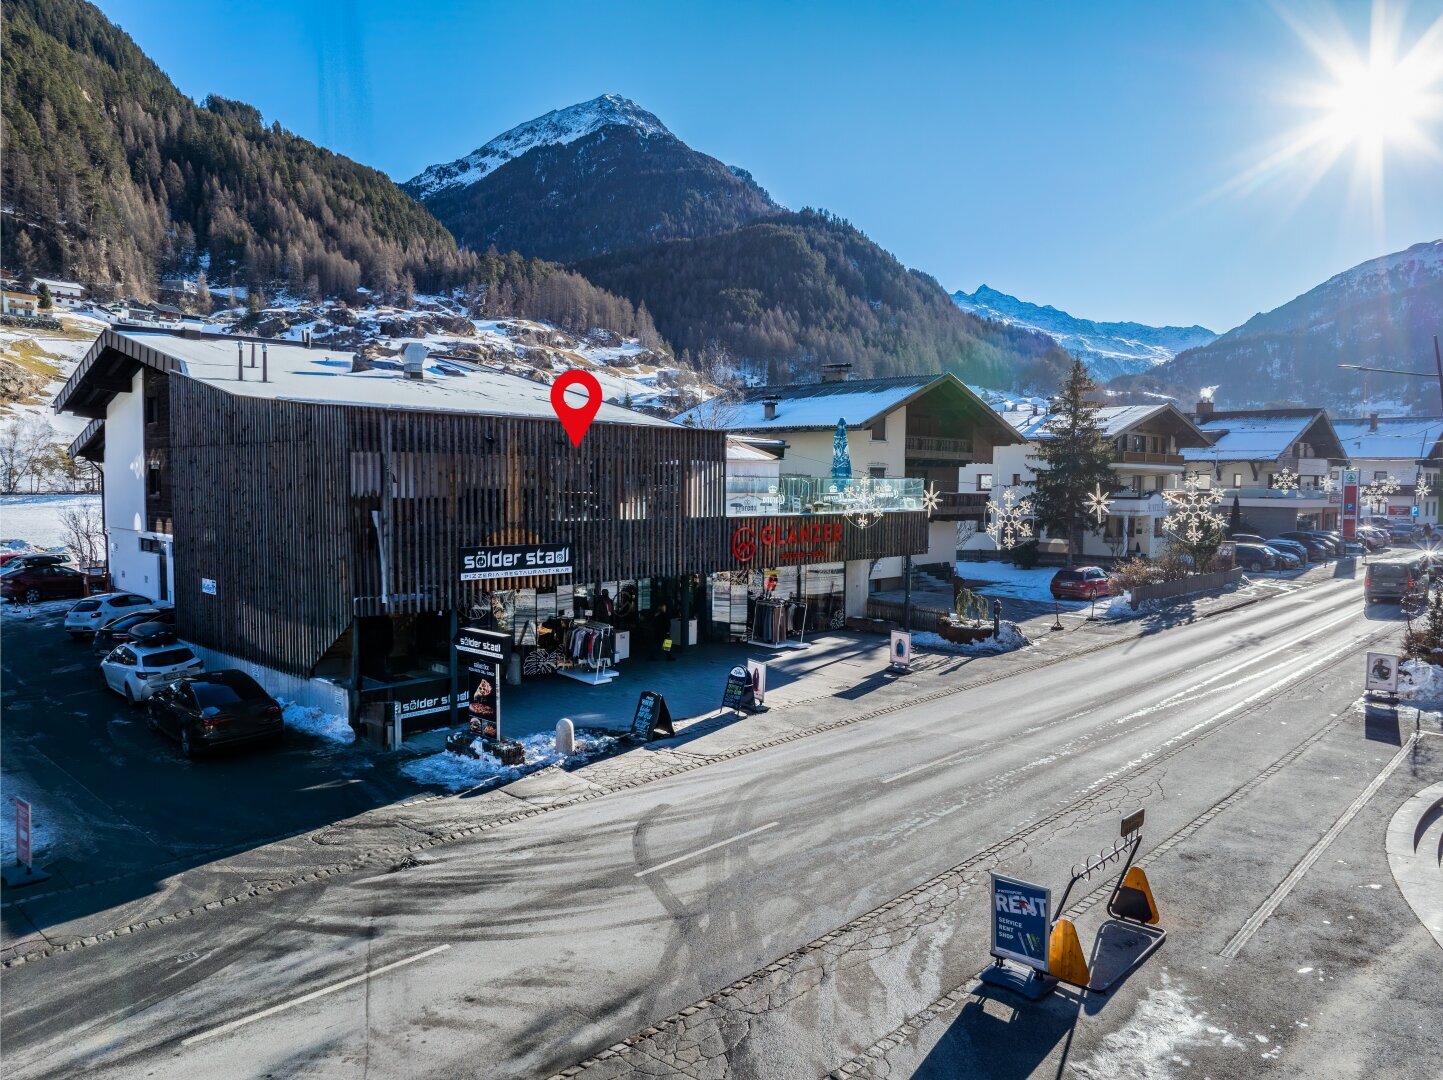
[0,568,1437,1077]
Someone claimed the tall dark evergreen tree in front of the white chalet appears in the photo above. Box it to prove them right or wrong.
[1032,360,1114,563]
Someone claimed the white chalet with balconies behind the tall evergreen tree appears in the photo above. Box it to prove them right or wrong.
[961,404,1208,560]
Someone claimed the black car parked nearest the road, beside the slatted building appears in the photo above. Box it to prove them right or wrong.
[147,670,286,758]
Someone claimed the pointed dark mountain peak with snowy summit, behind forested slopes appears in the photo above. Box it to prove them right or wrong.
[403,94,782,263]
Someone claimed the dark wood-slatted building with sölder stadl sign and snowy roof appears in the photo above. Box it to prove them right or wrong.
[56,328,928,731]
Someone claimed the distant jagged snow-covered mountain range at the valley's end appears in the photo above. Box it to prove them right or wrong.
[952,284,1218,380]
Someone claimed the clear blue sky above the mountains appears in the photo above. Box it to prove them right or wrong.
[100,0,1443,331]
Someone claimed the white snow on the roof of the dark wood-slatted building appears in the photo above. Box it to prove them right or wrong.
[123,331,672,427]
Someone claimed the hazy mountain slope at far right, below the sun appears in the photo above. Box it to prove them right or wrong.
[1154,240,1443,410]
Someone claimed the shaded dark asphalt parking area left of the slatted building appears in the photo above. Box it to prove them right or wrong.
[0,602,418,895]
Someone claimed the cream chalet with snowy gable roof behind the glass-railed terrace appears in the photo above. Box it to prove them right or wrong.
[677,364,1022,591]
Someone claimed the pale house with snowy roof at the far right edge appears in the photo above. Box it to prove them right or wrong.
[1333,413,1443,528]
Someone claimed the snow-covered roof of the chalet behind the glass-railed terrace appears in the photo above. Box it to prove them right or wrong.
[677,375,938,432]
